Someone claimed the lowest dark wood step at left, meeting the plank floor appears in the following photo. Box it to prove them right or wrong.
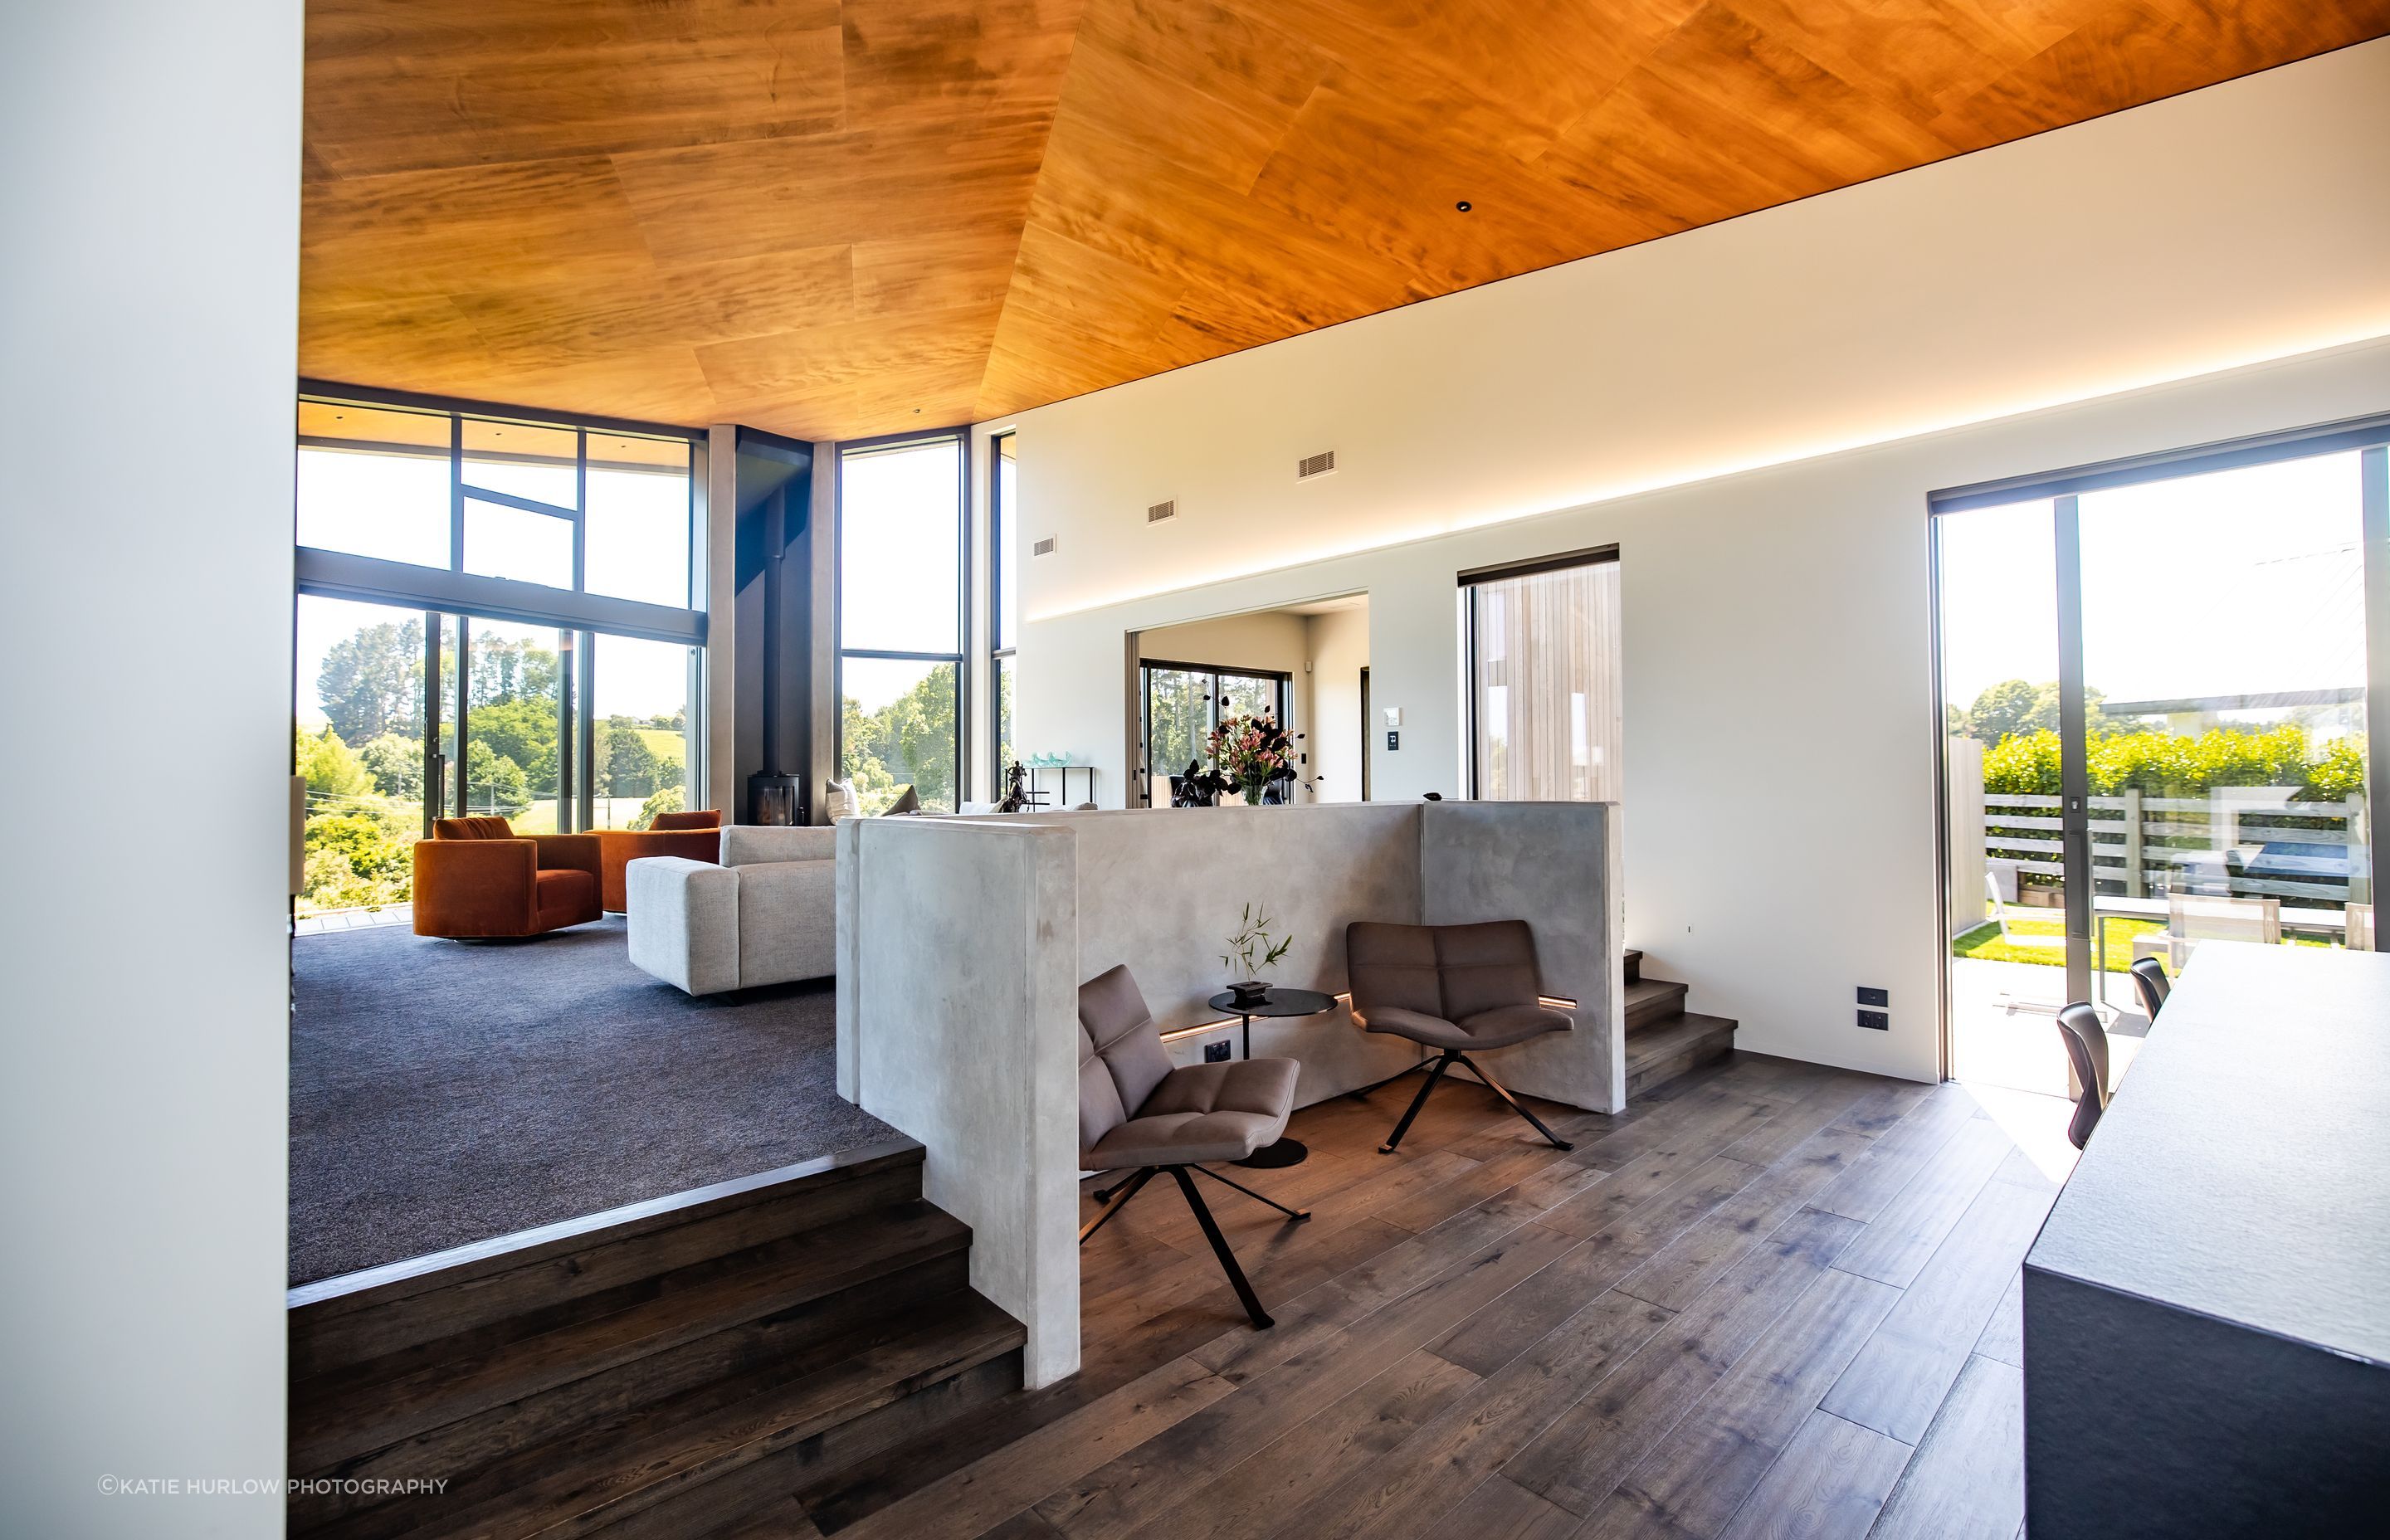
[354,1289,1027,1540]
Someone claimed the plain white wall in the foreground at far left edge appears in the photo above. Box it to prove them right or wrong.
[0,0,301,1540]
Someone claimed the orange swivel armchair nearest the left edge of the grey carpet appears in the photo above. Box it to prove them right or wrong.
[416,818,602,938]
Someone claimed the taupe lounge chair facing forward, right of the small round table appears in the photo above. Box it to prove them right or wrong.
[1345,921,1575,1155]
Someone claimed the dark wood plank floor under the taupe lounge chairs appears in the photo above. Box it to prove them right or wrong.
[793,1055,2065,1540]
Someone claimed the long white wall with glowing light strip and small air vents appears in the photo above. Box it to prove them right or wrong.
[998,41,2390,1079]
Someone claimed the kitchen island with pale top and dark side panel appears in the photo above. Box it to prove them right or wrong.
[2024,943,2390,1540]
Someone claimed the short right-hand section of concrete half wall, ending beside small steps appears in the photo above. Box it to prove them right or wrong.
[1420,801,1627,1112]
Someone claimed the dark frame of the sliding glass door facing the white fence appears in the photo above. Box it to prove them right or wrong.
[1926,412,2390,1079]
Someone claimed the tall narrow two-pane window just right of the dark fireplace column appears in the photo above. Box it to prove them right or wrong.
[839,433,968,813]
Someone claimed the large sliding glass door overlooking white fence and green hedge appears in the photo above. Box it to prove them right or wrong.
[1934,423,2390,1095]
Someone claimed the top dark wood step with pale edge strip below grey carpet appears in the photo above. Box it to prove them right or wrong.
[289,1138,923,1380]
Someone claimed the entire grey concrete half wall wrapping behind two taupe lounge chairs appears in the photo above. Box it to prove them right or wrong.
[839,803,1625,1385]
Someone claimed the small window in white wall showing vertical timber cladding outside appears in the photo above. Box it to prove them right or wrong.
[1461,548,1621,801]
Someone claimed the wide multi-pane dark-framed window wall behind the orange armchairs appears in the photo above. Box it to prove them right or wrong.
[291,387,705,911]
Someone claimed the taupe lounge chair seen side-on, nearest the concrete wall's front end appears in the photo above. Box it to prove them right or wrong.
[1078,968,1310,1328]
